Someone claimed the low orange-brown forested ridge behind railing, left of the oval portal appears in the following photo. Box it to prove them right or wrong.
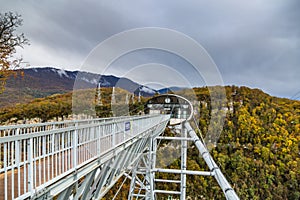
[0,88,145,125]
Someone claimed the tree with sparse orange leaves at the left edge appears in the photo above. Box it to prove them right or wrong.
[0,12,29,94]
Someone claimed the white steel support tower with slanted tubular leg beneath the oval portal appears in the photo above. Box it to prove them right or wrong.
[128,122,239,200]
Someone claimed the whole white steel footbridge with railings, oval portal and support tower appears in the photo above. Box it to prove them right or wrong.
[0,95,239,200]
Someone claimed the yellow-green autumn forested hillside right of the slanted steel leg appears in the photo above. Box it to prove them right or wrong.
[189,87,300,199]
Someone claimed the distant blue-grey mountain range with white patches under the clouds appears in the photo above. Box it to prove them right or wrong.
[0,67,179,107]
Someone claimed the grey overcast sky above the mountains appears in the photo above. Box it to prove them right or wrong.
[0,0,300,97]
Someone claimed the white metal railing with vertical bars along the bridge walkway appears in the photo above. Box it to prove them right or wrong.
[0,115,169,200]
